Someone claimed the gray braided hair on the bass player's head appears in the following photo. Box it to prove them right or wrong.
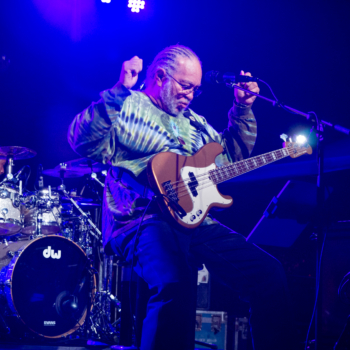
[145,44,202,86]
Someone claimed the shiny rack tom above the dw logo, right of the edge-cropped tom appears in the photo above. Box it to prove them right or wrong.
[21,189,61,235]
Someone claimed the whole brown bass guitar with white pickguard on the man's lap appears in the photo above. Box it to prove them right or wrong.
[147,142,312,228]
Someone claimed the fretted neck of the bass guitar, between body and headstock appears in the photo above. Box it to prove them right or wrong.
[209,147,294,185]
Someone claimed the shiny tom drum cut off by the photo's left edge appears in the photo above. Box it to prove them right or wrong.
[0,185,22,236]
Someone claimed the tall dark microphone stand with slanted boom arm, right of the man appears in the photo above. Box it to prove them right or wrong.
[225,80,350,350]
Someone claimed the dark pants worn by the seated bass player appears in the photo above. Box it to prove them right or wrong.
[111,219,292,350]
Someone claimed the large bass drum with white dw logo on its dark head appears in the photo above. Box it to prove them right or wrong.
[0,236,96,338]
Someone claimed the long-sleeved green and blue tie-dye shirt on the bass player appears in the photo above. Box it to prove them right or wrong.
[68,83,256,244]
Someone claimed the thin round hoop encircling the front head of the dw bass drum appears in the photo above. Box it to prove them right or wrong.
[8,235,97,339]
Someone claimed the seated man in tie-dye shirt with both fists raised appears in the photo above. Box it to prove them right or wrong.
[68,45,291,350]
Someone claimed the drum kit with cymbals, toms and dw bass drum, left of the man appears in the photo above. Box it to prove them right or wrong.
[0,147,117,344]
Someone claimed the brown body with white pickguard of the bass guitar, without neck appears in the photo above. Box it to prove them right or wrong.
[147,142,233,228]
